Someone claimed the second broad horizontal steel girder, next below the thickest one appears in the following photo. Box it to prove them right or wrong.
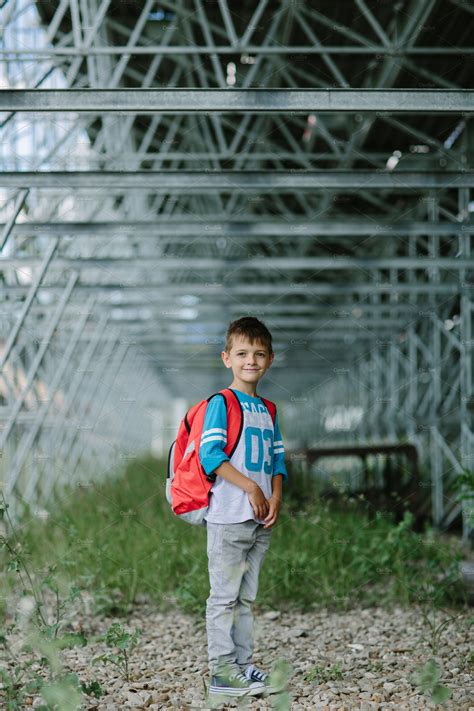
[0,172,474,194]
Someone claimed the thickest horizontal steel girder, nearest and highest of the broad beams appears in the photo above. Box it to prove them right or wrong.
[0,88,474,114]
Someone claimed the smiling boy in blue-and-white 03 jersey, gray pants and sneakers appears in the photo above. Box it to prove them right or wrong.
[199,317,288,696]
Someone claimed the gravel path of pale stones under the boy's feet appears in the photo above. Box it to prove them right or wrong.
[5,602,474,711]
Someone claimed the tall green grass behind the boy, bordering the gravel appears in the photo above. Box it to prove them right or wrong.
[1,456,462,615]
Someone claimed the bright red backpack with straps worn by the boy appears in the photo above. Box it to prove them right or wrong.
[166,388,276,526]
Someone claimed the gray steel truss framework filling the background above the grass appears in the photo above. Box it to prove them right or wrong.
[0,0,474,541]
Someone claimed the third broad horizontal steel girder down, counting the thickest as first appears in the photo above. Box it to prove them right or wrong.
[7,221,474,240]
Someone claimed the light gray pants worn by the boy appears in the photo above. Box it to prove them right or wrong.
[206,519,272,675]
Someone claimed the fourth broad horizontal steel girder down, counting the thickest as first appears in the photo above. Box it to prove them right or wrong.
[0,255,474,268]
